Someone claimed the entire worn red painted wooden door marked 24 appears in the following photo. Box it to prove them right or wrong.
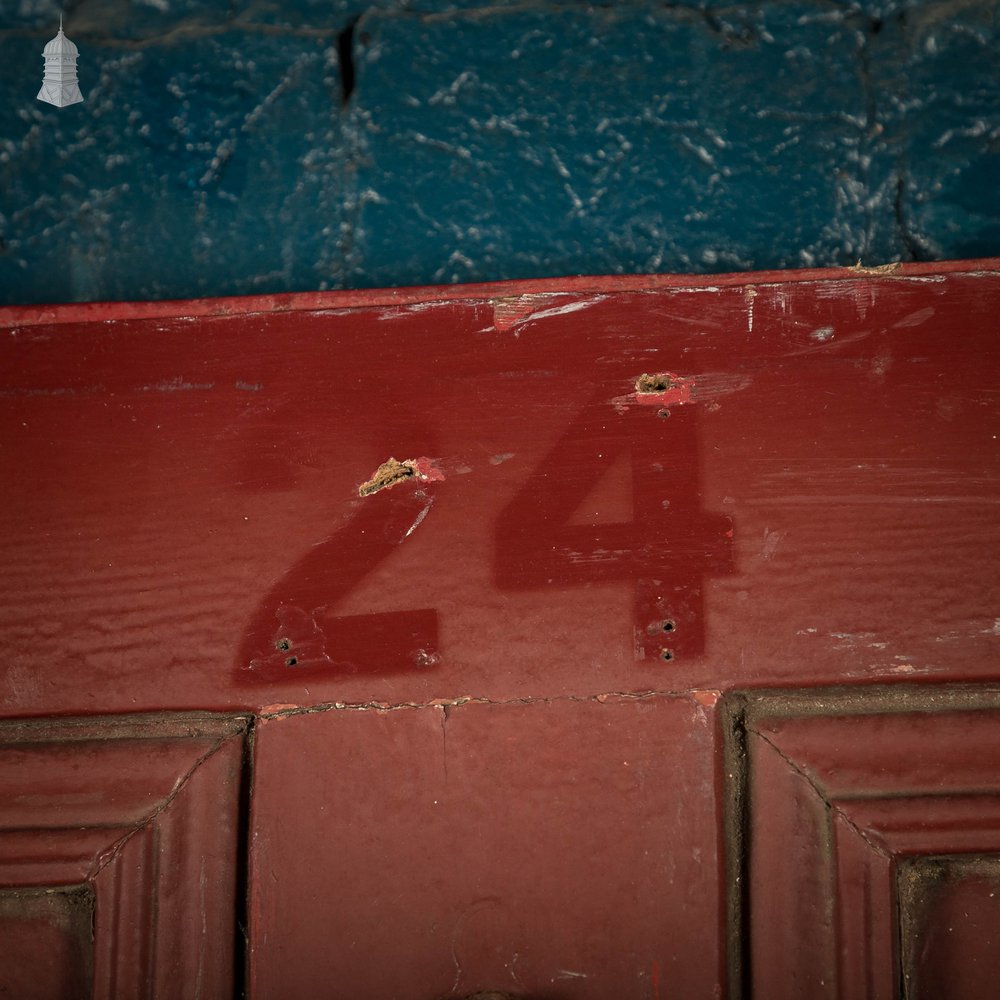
[0,262,1000,1000]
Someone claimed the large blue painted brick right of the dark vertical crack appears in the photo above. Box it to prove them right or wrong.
[351,5,895,284]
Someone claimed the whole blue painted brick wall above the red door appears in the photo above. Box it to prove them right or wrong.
[0,0,1000,303]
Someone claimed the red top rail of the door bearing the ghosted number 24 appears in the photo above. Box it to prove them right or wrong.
[0,262,1000,714]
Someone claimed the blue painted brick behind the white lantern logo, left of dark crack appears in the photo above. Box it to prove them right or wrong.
[0,32,345,302]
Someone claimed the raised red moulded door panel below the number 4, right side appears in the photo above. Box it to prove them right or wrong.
[724,685,1000,1000]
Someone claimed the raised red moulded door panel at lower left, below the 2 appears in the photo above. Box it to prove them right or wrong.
[0,714,248,1000]
